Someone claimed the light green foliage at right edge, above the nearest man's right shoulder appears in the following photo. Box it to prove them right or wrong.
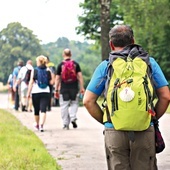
[120,0,170,81]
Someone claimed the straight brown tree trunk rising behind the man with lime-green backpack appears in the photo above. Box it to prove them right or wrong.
[99,0,112,60]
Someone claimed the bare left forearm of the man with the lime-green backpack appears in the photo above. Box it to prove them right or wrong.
[83,90,103,124]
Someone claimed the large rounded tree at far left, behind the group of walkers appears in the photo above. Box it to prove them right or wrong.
[0,22,42,83]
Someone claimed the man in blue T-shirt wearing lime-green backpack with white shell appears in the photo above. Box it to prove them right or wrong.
[83,25,170,170]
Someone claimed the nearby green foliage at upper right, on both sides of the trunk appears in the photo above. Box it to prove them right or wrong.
[77,0,170,81]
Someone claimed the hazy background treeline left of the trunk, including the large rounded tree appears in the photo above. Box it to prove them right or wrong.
[0,23,101,86]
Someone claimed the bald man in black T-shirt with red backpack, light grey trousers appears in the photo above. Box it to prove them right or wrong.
[55,49,84,130]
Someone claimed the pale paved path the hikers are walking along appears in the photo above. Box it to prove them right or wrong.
[0,94,170,170]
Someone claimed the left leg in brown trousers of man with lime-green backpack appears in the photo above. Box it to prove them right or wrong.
[104,128,132,170]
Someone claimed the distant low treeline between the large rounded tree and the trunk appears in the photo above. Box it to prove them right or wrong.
[42,37,101,87]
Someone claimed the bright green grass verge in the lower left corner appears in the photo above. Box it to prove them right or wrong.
[0,109,61,170]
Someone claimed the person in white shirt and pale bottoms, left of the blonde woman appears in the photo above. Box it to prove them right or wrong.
[13,60,33,112]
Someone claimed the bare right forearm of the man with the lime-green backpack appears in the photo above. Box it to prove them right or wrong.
[155,86,170,119]
